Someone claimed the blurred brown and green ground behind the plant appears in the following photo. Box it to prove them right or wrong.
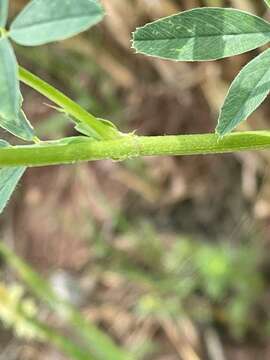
[0,0,270,360]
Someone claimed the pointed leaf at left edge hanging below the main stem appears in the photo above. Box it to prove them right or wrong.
[0,140,26,213]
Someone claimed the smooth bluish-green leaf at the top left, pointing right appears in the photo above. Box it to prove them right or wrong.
[10,0,104,46]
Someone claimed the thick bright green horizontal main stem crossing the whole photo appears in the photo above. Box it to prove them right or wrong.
[0,131,270,166]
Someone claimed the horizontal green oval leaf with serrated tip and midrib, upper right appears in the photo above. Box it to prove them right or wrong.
[133,8,270,61]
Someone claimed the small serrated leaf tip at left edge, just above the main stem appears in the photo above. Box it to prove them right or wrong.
[0,110,35,141]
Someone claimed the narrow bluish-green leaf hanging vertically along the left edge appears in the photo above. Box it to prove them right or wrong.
[0,38,21,119]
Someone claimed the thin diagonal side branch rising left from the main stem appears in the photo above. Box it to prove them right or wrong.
[19,66,120,140]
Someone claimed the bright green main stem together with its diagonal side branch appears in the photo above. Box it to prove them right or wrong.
[4,67,270,167]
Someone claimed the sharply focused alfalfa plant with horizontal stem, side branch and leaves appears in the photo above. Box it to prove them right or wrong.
[0,0,270,210]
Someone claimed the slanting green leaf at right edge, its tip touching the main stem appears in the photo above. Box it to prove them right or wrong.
[216,49,270,136]
